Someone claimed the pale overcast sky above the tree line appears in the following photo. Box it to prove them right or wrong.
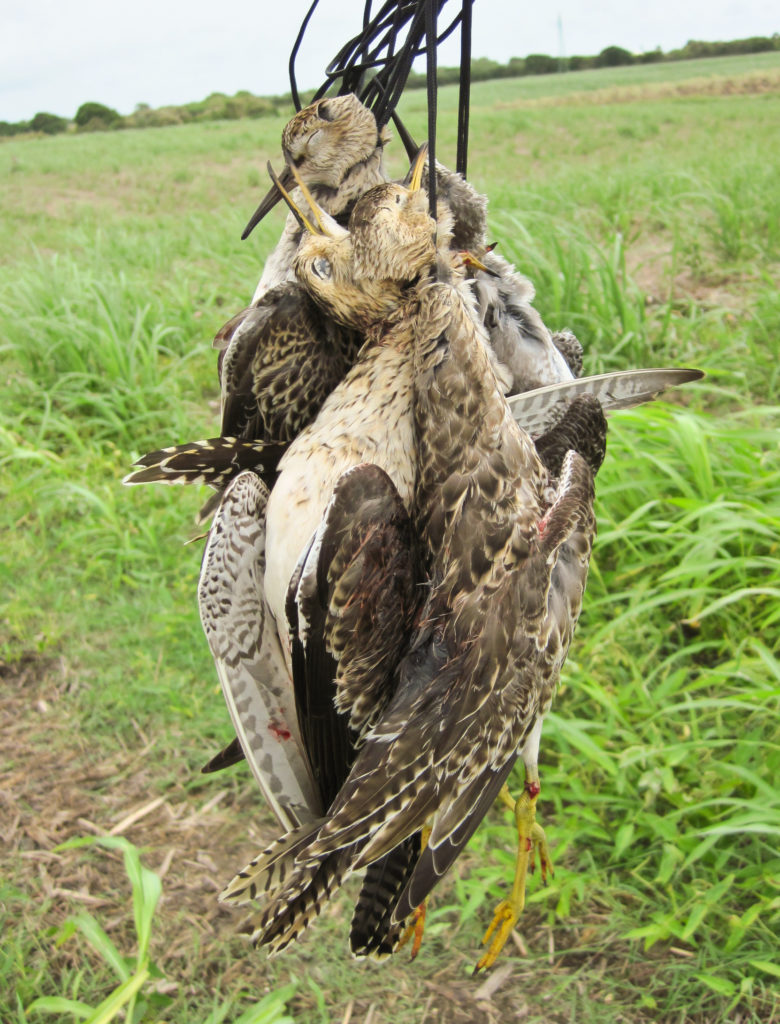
[0,0,780,121]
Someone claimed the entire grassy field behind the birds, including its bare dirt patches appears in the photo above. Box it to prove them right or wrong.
[0,54,780,1024]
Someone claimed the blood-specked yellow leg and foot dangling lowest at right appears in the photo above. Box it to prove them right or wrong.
[474,782,553,974]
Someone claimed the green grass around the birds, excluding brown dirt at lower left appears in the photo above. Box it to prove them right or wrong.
[0,64,780,1024]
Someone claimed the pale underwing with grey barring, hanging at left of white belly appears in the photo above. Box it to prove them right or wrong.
[198,472,320,830]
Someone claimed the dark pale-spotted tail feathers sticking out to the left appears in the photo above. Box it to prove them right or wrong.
[122,437,287,488]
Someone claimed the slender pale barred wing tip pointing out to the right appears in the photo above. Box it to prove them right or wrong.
[507,368,704,436]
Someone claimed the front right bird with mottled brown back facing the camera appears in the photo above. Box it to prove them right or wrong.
[215,151,604,962]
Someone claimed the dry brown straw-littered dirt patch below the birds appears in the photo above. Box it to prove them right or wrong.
[0,657,667,1024]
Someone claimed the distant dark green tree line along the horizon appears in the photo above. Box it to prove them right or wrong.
[0,33,780,137]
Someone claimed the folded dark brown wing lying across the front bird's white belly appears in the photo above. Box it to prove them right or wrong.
[286,465,416,807]
